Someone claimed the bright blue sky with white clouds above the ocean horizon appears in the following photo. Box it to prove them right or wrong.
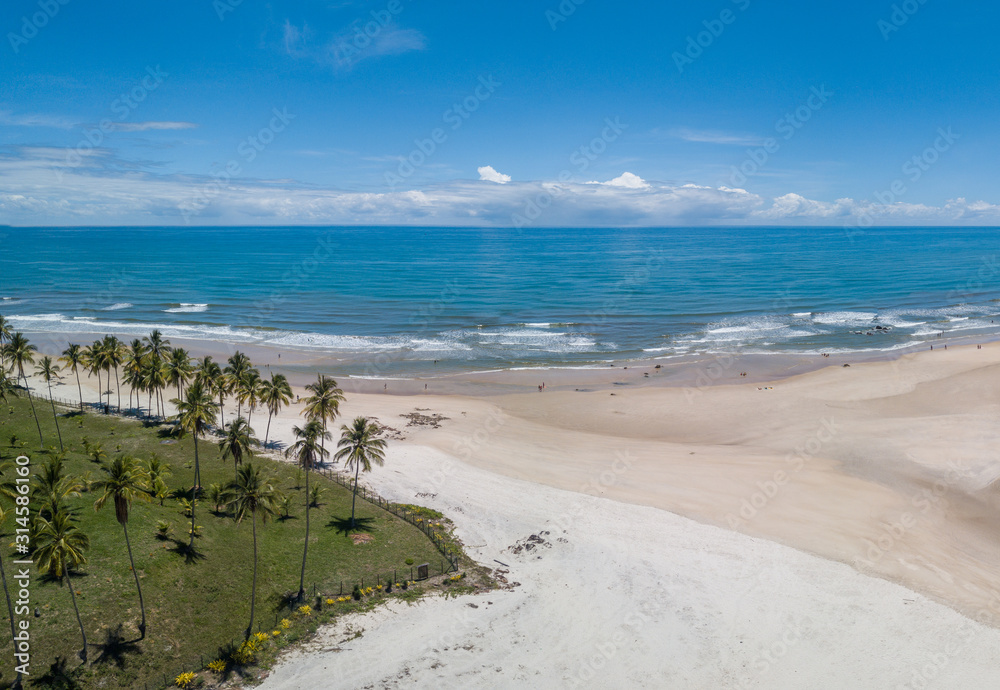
[0,0,1000,226]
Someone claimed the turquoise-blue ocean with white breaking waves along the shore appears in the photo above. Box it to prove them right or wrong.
[0,227,1000,374]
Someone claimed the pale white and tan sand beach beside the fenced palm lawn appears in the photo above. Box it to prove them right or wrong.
[17,338,1000,689]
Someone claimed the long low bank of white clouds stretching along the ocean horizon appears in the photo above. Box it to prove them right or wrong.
[0,147,1000,227]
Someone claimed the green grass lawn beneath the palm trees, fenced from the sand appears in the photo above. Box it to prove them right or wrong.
[0,398,441,688]
